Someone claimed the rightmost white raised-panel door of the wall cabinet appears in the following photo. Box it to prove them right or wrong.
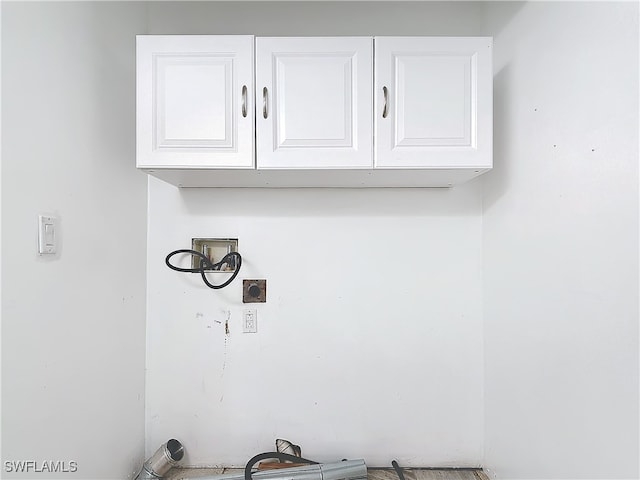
[375,37,493,168]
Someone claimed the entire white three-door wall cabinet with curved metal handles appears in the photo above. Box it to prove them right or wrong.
[137,35,492,187]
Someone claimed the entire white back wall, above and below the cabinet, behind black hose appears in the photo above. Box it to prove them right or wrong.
[146,2,483,466]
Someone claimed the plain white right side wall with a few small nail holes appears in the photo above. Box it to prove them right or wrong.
[483,2,640,479]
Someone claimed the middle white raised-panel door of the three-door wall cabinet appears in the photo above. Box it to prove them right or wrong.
[256,37,373,169]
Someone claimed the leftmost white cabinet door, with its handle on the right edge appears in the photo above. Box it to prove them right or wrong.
[137,35,255,168]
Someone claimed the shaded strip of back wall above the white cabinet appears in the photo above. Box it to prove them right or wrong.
[148,0,483,36]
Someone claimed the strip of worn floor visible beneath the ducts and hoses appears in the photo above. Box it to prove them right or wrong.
[162,468,489,480]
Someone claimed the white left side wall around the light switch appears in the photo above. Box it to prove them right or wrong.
[2,2,146,479]
